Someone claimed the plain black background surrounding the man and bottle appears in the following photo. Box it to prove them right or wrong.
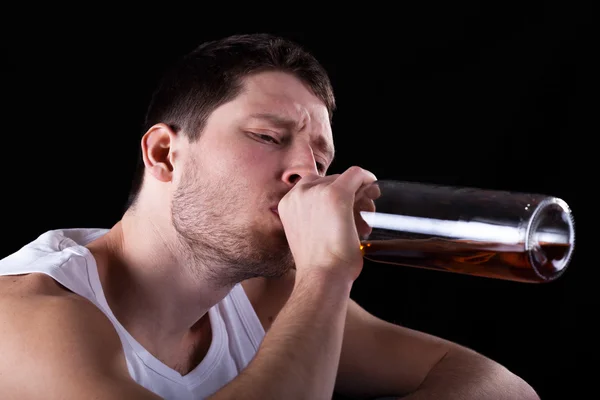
[0,2,600,399]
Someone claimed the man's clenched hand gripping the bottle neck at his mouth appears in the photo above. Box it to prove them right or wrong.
[278,167,377,281]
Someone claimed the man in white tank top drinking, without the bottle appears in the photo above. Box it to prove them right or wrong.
[0,35,537,400]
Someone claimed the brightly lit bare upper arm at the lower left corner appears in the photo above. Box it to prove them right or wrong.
[0,276,158,400]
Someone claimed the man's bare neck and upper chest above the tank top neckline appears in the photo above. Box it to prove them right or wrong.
[87,206,231,350]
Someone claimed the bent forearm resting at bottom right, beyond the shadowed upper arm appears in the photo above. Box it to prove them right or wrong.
[402,348,539,400]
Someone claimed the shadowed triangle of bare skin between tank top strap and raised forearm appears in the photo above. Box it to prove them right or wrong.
[242,269,296,331]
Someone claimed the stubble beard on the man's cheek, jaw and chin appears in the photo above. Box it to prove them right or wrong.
[171,159,294,287]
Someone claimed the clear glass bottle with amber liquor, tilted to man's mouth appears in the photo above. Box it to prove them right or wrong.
[357,180,575,283]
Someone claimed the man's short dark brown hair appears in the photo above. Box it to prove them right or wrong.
[126,33,335,208]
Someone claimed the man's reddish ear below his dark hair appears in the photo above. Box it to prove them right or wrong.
[141,123,176,182]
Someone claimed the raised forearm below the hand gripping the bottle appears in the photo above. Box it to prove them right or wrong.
[212,270,351,400]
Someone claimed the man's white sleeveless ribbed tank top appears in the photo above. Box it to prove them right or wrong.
[0,229,265,399]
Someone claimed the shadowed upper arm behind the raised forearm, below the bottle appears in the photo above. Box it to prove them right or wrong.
[336,300,455,397]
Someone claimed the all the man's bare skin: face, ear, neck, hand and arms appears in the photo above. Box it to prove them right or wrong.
[0,72,537,400]
